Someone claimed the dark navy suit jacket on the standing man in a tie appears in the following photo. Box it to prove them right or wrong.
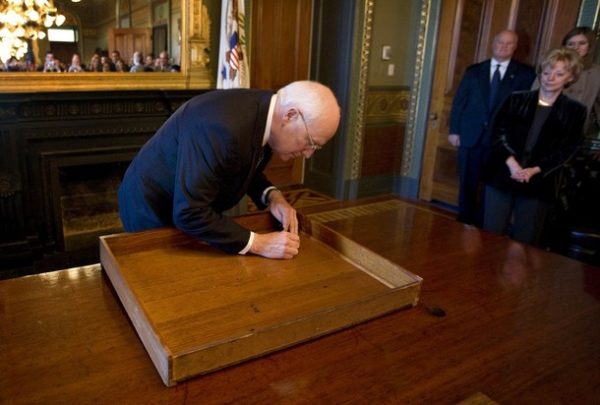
[450,59,535,148]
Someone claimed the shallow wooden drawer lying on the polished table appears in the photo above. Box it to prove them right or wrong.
[100,213,421,386]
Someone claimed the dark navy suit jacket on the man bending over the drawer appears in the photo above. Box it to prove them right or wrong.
[118,89,273,253]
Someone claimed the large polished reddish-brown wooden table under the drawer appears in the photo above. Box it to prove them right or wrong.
[0,199,600,404]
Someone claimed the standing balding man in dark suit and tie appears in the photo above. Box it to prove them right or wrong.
[448,30,535,226]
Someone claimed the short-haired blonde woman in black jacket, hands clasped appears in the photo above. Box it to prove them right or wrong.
[483,48,587,244]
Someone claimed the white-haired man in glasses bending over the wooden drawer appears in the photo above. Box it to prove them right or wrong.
[118,81,340,258]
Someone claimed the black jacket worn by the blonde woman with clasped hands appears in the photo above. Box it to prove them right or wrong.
[487,90,587,201]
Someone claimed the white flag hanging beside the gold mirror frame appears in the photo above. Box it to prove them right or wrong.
[217,0,250,89]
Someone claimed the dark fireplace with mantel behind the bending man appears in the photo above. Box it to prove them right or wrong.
[0,91,199,278]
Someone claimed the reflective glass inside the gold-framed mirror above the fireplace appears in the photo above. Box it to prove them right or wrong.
[0,0,182,72]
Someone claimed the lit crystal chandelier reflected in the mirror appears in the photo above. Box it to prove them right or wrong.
[0,0,65,62]
